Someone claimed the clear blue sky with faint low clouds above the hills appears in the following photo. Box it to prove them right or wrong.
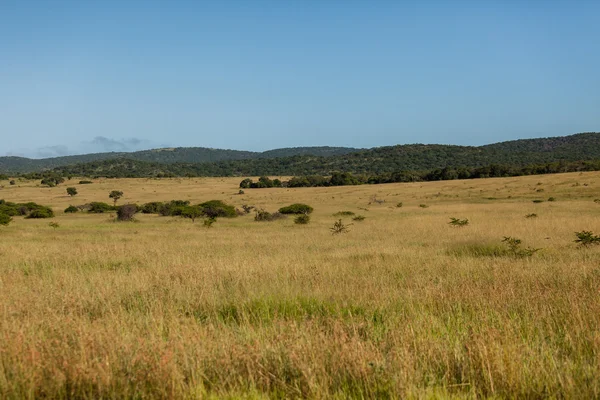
[0,0,600,157]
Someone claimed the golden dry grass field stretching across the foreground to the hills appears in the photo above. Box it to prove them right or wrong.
[0,172,600,399]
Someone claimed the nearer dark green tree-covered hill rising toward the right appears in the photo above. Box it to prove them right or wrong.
[0,133,600,177]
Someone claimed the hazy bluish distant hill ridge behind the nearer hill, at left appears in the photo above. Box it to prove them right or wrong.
[0,147,359,173]
